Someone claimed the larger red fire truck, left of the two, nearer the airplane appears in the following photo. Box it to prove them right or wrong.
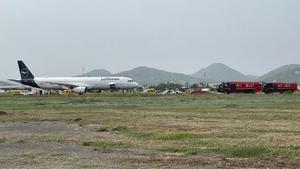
[218,82,262,94]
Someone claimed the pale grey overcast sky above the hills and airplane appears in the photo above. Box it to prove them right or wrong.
[0,0,300,79]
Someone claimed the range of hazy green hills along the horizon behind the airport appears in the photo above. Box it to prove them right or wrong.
[69,63,300,84]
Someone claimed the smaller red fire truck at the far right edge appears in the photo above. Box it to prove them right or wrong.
[263,82,298,94]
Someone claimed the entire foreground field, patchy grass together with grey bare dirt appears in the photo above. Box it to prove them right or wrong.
[0,93,300,168]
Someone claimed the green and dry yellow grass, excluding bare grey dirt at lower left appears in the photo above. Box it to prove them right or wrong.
[0,94,300,168]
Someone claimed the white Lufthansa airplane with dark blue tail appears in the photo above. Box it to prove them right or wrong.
[9,60,139,94]
